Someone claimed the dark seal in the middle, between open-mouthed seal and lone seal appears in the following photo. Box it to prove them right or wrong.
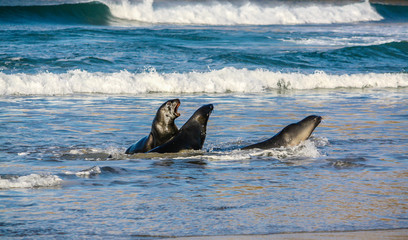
[149,104,214,153]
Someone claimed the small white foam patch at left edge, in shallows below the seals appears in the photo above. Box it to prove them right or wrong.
[0,174,62,189]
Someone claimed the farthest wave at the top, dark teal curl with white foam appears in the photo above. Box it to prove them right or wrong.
[0,0,388,25]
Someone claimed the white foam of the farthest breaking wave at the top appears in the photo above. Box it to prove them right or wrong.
[105,0,383,25]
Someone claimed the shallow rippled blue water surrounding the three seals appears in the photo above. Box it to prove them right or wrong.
[0,89,408,238]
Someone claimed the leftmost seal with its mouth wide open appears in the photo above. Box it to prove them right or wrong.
[125,99,180,154]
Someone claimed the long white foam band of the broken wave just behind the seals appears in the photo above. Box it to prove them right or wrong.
[0,67,408,95]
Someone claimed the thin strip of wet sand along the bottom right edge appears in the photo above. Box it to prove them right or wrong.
[164,229,408,240]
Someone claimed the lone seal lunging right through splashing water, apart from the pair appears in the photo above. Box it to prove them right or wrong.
[241,115,322,150]
